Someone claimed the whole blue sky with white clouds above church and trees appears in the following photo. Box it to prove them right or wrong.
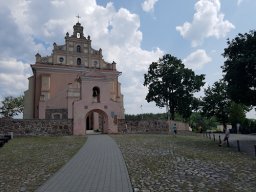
[0,0,256,118]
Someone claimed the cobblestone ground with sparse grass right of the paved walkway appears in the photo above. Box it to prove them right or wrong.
[113,135,256,192]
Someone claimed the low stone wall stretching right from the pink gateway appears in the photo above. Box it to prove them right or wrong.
[118,119,189,133]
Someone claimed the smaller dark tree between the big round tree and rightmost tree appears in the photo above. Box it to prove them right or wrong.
[202,80,231,128]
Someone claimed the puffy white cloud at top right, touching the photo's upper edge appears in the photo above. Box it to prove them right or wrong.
[176,0,235,47]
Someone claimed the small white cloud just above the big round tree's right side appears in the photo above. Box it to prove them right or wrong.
[183,49,212,70]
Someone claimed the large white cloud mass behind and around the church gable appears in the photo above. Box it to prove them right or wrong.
[0,0,163,113]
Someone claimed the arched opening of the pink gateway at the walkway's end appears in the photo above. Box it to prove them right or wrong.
[85,109,108,134]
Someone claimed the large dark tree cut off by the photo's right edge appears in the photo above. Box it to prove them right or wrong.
[222,31,256,106]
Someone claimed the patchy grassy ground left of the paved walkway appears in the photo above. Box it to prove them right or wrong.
[0,136,86,192]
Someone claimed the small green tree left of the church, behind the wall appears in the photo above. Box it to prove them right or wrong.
[0,96,24,117]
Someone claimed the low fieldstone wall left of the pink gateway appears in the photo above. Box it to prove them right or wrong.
[0,118,73,136]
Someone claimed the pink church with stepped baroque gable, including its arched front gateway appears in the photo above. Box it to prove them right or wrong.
[23,22,124,135]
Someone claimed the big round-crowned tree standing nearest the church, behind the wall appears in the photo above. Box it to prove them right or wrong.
[144,54,204,120]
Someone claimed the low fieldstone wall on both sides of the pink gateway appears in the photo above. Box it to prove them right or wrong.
[0,118,189,136]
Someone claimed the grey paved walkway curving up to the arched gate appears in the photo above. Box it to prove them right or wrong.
[37,135,132,192]
